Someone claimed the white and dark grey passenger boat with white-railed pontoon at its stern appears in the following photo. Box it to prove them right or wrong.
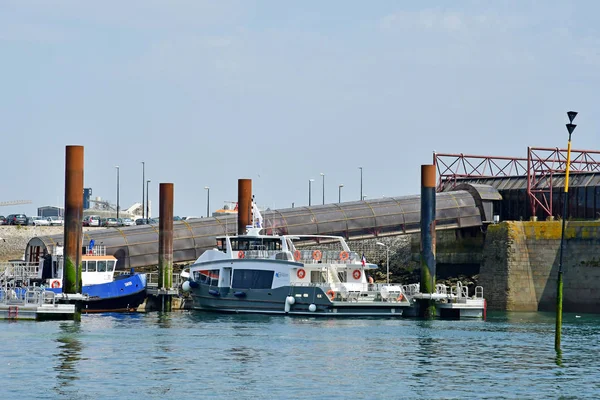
[183,205,484,317]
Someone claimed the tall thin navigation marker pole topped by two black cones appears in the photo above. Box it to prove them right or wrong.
[554,111,577,352]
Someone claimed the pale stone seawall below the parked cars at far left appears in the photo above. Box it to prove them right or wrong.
[0,225,101,262]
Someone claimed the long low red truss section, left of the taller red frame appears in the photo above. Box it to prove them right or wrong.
[433,153,527,192]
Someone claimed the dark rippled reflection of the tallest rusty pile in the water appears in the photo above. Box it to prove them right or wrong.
[54,322,83,395]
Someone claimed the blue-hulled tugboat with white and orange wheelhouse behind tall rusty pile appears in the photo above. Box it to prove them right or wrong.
[32,242,146,313]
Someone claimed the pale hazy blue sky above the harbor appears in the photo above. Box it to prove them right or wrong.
[0,0,600,216]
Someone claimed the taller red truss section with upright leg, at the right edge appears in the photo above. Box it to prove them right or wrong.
[527,147,600,216]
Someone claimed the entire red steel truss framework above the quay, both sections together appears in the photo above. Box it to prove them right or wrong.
[433,147,600,216]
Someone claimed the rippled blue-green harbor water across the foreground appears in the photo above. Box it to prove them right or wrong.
[0,311,600,400]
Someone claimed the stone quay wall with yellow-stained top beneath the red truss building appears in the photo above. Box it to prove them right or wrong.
[479,221,600,313]
